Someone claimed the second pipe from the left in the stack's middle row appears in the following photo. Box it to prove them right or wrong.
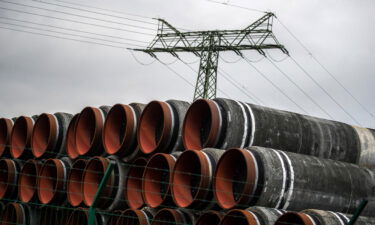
[18,159,42,203]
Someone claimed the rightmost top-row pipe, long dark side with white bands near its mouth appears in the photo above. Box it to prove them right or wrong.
[183,98,375,168]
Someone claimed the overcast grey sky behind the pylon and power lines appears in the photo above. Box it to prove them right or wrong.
[0,0,375,127]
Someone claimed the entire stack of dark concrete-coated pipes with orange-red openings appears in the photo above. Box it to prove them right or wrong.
[0,98,375,225]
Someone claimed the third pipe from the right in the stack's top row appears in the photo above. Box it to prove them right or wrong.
[103,103,145,162]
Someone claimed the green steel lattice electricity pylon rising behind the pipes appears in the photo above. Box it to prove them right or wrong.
[134,13,289,100]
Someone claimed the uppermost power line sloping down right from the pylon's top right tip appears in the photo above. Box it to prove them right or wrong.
[277,18,375,119]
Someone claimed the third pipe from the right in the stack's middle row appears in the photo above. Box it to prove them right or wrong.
[142,153,178,208]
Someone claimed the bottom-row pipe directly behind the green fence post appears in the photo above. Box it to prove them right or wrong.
[65,208,108,225]
